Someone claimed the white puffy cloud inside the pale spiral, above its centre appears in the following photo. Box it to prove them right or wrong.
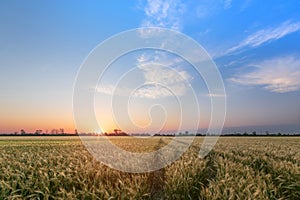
[97,52,192,99]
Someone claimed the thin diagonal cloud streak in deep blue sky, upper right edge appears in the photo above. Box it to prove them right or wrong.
[227,21,300,53]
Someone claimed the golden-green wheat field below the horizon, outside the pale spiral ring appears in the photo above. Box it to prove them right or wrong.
[0,137,300,199]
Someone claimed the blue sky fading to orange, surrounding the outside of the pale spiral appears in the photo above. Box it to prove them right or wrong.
[0,0,300,132]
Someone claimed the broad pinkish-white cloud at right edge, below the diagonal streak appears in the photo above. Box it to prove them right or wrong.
[230,57,300,93]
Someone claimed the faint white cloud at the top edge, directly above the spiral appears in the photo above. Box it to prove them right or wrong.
[142,0,185,30]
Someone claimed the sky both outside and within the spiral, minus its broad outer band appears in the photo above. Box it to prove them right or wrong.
[0,0,300,133]
